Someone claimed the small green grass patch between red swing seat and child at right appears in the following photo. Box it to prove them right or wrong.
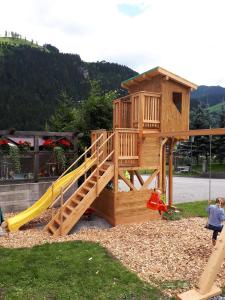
[175,201,208,218]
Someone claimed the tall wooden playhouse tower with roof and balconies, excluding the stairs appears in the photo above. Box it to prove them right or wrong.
[89,67,197,225]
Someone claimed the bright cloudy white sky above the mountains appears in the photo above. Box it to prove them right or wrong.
[0,0,225,87]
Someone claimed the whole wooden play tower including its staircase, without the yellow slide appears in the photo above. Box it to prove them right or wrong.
[47,67,197,235]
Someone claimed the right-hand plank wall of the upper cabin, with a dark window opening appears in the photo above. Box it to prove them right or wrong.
[161,80,190,132]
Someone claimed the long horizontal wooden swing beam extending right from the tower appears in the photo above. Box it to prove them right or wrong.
[143,128,225,138]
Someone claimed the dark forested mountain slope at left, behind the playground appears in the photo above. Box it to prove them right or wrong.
[0,35,137,130]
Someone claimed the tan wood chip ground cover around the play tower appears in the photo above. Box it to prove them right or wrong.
[0,214,225,295]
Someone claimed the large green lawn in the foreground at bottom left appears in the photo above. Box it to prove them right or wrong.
[0,241,165,300]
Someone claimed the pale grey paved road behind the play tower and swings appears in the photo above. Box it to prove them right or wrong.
[119,175,225,203]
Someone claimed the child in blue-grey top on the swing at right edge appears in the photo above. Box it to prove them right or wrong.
[206,198,225,246]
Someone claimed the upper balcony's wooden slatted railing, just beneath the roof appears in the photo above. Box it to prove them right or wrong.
[113,91,161,131]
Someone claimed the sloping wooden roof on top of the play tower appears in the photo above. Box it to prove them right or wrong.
[121,67,198,90]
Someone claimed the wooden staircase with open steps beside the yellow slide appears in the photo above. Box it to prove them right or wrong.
[46,163,114,236]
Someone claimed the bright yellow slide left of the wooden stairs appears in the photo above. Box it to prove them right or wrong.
[6,158,94,231]
